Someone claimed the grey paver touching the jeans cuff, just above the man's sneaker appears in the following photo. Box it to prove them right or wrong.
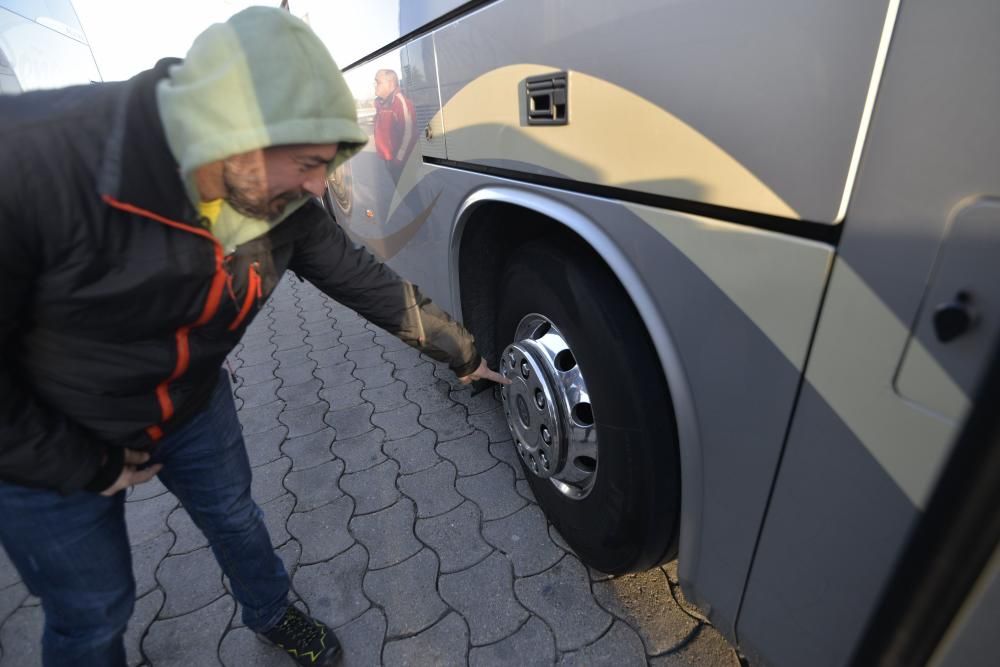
[292,544,371,627]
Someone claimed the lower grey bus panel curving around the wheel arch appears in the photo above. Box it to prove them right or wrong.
[374,154,831,637]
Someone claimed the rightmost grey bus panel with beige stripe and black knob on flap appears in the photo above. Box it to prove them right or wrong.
[737,0,1000,665]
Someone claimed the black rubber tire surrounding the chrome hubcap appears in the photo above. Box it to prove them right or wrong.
[497,240,680,574]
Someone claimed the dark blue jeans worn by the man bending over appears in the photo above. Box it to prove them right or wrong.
[0,374,289,667]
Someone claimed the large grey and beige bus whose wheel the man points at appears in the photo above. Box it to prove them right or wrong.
[290,0,1000,665]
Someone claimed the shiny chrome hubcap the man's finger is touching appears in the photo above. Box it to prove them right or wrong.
[500,313,598,500]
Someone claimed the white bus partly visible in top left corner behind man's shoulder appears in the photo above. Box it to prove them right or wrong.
[0,0,101,95]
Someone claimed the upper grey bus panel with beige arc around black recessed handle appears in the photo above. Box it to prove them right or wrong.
[435,0,888,222]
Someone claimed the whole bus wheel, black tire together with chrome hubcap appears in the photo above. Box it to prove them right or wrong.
[497,241,680,573]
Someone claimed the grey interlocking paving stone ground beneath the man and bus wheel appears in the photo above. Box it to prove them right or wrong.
[0,277,739,667]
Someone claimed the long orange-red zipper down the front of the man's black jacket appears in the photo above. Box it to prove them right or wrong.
[101,195,227,442]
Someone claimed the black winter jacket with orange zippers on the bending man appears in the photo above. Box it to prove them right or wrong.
[0,61,479,493]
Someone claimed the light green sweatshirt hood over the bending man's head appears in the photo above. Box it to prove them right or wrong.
[156,7,368,249]
